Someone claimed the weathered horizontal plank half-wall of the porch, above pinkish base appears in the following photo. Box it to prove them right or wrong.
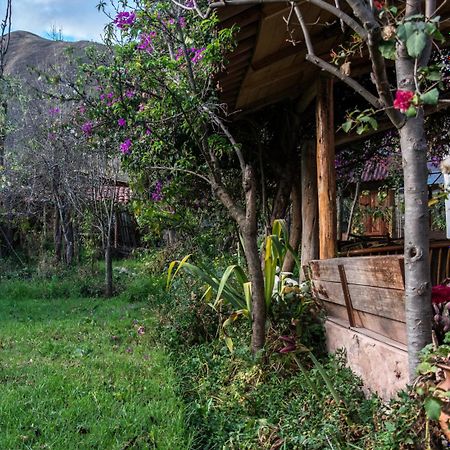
[310,255,406,344]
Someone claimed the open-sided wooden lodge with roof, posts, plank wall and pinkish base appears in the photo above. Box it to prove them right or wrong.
[211,0,450,398]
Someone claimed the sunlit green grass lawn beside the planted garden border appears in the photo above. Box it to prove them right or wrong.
[0,281,190,450]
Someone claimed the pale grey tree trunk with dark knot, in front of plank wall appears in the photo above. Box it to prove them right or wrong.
[395,4,432,381]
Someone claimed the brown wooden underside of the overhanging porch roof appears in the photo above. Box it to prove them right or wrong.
[213,0,450,116]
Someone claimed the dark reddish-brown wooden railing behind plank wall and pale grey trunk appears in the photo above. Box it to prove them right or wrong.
[339,240,450,285]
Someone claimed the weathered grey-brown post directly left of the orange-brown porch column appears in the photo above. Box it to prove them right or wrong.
[300,142,319,280]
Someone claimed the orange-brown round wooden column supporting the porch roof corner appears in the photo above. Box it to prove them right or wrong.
[316,76,337,259]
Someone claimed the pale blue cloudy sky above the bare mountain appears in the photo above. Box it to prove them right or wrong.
[6,0,116,42]
